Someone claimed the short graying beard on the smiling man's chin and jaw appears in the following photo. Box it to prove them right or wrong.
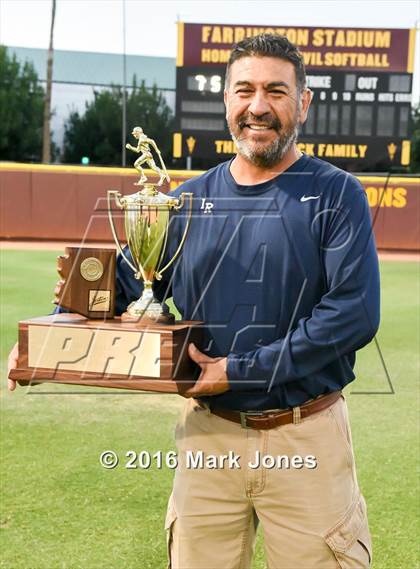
[230,125,298,168]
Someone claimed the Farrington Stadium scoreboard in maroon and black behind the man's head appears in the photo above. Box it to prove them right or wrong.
[173,23,416,172]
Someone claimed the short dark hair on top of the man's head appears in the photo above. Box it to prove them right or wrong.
[225,34,306,91]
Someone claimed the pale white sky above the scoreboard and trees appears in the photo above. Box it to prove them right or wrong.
[0,0,420,100]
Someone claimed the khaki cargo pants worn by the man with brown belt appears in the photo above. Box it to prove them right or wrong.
[166,397,372,569]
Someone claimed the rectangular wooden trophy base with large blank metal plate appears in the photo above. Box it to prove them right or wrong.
[9,314,202,394]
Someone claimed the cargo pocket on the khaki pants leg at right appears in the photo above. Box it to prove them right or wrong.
[325,494,372,569]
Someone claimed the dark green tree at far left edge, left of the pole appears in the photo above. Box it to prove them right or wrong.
[0,45,44,162]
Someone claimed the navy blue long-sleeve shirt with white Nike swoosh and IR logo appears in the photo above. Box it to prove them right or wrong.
[117,155,379,410]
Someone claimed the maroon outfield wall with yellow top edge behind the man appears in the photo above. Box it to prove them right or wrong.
[0,162,420,251]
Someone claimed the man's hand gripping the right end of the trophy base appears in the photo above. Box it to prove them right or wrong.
[182,344,229,397]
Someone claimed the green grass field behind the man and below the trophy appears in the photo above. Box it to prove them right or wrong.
[0,251,420,569]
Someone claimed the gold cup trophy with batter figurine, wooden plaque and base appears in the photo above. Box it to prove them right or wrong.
[9,127,202,393]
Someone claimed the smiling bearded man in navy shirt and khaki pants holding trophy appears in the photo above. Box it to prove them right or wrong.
[9,34,379,569]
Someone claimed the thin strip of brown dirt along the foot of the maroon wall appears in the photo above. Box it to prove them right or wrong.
[0,240,420,262]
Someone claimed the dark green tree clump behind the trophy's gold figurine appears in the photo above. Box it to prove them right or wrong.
[62,79,173,166]
